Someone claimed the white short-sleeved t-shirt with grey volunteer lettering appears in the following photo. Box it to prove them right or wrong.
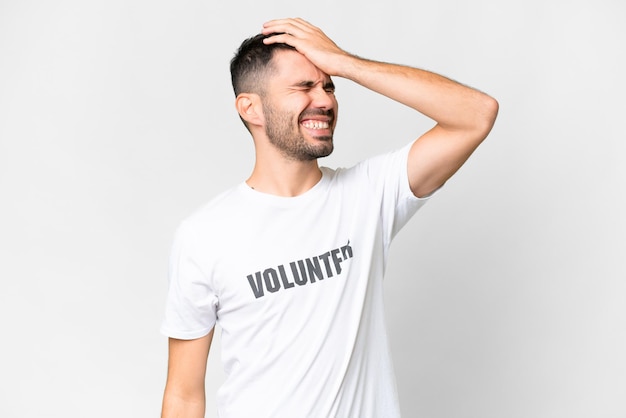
[162,146,434,418]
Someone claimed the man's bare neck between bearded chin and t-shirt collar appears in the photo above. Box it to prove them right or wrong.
[246,155,322,197]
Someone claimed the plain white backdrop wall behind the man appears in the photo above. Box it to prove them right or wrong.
[0,0,626,418]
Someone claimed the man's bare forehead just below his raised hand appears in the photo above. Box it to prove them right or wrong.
[269,50,330,85]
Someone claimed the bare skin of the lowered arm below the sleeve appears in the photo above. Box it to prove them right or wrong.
[161,330,213,418]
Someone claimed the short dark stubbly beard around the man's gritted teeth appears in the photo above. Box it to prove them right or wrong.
[263,102,335,161]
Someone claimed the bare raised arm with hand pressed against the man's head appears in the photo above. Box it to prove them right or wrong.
[262,19,498,197]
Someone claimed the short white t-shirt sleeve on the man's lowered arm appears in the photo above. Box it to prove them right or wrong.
[161,223,218,340]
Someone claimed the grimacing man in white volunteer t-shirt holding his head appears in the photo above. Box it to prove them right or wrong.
[162,19,498,418]
